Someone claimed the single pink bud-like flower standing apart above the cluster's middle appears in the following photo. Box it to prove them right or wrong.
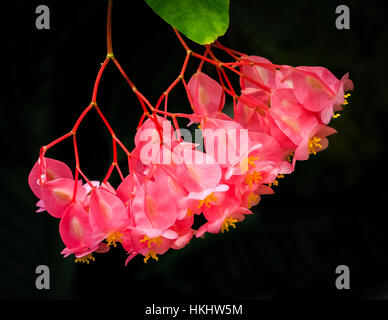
[187,72,225,117]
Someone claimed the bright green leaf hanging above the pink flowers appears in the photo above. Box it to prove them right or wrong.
[145,0,229,44]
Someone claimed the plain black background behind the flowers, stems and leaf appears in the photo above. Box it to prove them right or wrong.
[0,0,388,299]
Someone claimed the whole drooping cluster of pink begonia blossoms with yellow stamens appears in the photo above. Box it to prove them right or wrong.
[29,49,353,263]
